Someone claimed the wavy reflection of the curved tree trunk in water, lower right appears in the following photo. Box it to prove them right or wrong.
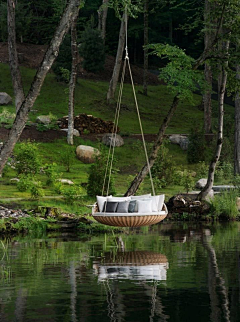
[203,236,230,322]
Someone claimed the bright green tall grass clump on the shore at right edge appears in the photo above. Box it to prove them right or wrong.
[210,190,238,219]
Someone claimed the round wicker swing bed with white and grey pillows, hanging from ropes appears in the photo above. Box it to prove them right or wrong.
[92,8,168,227]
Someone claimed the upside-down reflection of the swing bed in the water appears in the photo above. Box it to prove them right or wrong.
[93,251,168,282]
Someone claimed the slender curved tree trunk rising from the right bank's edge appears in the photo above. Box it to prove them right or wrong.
[198,41,229,200]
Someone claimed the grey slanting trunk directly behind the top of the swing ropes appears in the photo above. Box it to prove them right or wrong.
[107,13,128,103]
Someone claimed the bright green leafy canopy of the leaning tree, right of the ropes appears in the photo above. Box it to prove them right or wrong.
[148,44,205,103]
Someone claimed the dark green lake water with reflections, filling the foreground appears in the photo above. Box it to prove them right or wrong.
[0,222,240,322]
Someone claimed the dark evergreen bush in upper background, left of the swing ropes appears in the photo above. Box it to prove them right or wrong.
[79,26,105,73]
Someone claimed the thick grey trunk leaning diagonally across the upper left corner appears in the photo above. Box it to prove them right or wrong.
[0,0,80,173]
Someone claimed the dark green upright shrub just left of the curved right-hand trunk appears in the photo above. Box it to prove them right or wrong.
[187,126,205,163]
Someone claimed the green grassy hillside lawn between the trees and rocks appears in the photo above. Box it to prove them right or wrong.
[0,64,234,211]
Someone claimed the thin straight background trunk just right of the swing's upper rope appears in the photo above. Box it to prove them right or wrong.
[143,0,149,96]
